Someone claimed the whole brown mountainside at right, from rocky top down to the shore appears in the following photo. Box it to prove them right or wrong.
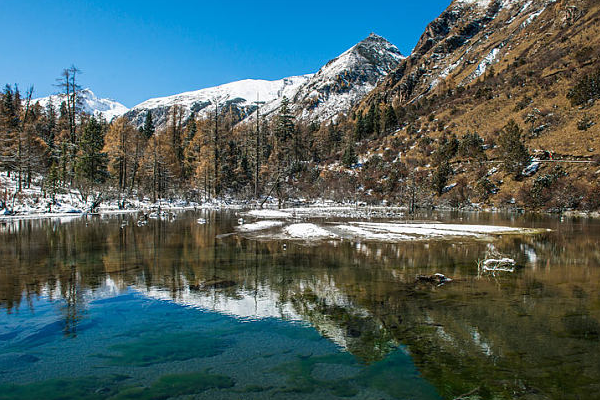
[356,0,600,208]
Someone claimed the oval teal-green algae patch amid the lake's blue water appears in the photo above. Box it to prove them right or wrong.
[98,333,229,367]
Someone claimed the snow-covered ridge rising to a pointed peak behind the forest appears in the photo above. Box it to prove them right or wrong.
[126,34,404,126]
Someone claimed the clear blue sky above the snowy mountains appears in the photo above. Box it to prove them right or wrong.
[0,0,450,107]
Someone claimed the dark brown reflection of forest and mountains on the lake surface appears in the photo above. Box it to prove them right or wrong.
[0,212,600,398]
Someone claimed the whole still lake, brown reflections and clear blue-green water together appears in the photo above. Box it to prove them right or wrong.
[0,211,600,399]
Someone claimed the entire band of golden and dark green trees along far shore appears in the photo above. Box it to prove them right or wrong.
[0,67,598,210]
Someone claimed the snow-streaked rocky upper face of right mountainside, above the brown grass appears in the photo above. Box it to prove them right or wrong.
[364,0,581,103]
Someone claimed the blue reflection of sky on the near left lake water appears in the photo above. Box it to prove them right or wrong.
[0,280,437,399]
